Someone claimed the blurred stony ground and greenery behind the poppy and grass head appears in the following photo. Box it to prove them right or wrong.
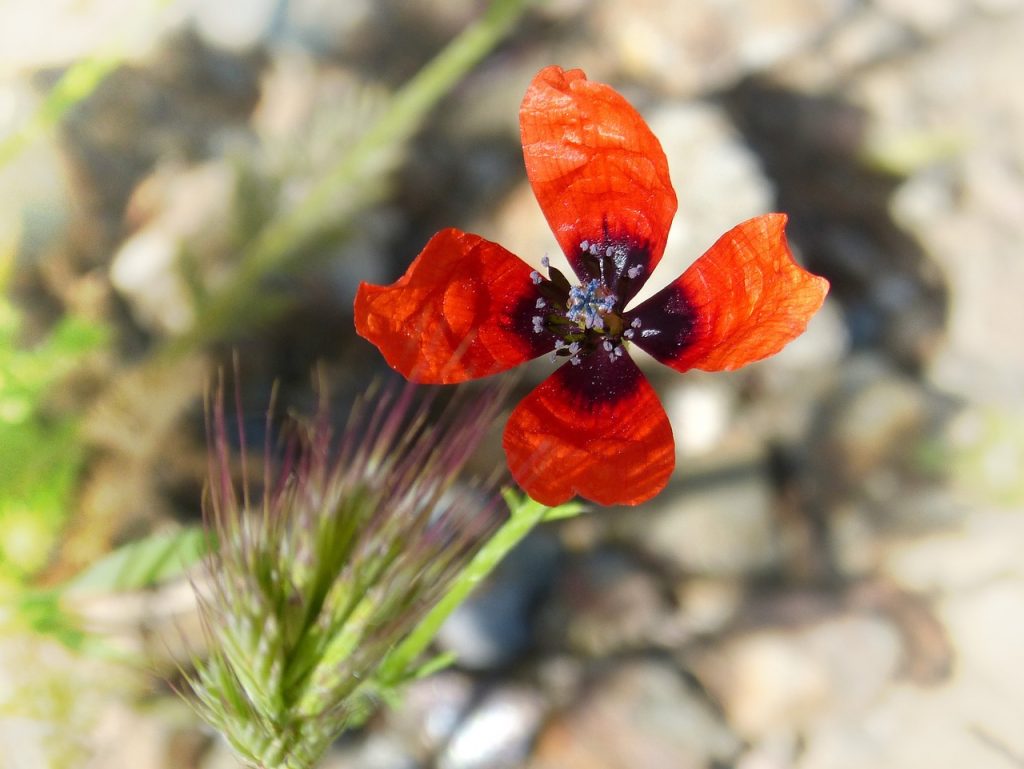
[0,0,1024,769]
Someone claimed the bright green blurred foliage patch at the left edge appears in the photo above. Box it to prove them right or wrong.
[0,298,106,591]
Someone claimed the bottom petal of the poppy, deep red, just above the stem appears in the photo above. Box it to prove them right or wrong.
[504,350,676,505]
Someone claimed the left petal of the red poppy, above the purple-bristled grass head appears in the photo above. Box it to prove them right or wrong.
[354,229,554,384]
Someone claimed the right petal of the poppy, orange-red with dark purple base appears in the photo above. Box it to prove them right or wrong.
[626,214,828,371]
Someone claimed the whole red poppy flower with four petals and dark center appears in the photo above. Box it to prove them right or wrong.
[355,67,828,505]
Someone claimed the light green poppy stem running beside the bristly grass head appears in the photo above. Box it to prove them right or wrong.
[377,495,551,687]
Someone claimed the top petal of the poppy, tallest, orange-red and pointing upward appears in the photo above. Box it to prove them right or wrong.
[519,67,676,303]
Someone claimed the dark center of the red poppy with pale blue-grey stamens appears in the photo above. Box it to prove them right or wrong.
[530,257,640,366]
